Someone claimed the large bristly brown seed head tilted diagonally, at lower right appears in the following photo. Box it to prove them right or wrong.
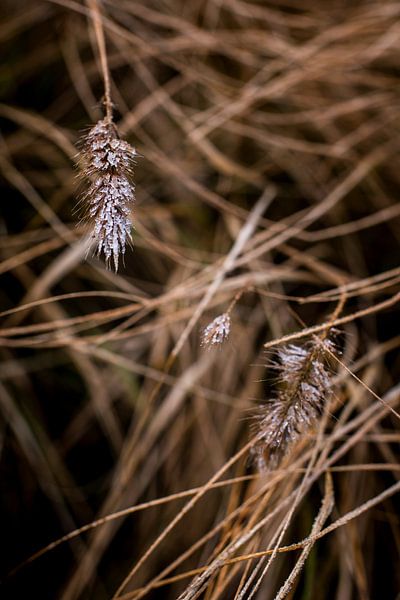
[253,340,334,469]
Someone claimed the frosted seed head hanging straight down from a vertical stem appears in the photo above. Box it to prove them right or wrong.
[78,119,136,271]
